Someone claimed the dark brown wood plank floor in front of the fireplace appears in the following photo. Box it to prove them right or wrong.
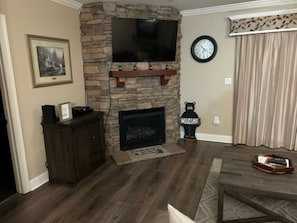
[0,141,227,223]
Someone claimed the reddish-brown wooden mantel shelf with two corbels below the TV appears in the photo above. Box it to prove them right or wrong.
[109,70,176,87]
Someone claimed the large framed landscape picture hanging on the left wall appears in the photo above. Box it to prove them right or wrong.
[27,35,72,88]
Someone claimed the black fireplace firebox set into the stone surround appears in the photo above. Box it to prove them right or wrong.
[119,107,165,150]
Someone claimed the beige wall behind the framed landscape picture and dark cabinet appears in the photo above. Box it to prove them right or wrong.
[0,0,85,179]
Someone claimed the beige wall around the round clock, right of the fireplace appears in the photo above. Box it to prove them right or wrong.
[181,4,296,139]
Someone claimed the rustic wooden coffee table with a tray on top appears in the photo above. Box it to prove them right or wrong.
[217,147,297,223]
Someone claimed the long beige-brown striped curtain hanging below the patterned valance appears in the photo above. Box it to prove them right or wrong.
[233,32,297,150]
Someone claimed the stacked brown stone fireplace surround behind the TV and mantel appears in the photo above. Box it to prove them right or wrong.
[80,2,181,155]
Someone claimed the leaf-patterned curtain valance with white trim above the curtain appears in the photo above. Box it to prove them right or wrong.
[229,9,297,36]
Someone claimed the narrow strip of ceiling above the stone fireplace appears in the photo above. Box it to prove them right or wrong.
[75,0,260,11]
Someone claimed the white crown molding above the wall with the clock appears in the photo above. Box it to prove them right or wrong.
[180,0,297,16]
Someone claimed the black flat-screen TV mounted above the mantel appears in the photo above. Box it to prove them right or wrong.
[112,17,178,62]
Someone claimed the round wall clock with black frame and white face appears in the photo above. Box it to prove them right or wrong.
[191,36,218,63]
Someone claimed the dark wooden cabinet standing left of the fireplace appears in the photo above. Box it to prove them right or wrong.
[42,112,105,184]
